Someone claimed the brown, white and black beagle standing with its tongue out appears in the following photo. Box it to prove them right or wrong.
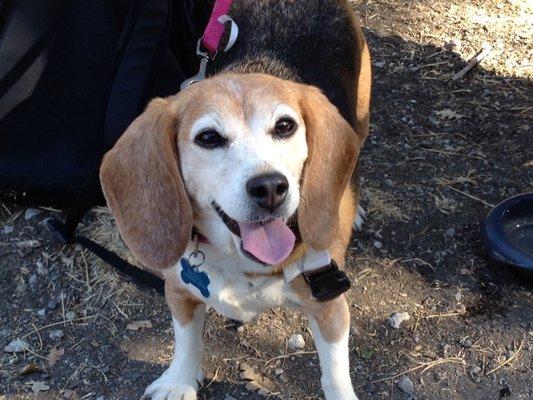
[100,0,370,400]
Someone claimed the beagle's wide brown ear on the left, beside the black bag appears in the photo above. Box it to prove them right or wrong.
[100,99,193,268]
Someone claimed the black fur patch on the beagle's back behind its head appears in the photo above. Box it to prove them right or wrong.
[205,0,359,124]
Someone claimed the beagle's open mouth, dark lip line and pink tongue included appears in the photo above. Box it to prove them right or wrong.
[212,202,296,265]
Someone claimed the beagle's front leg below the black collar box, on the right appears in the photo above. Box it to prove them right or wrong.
[306,295,357,400]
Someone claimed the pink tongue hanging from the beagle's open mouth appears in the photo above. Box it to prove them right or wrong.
[239,218,296,265]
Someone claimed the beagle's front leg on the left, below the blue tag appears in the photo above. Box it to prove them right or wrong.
[142,280,205,400]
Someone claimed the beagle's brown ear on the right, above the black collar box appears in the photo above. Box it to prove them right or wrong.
[298,87,361,250]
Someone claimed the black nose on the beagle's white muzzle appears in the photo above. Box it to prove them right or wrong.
[246,172,289,212]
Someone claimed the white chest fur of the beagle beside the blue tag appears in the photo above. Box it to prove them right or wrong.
[171,241,290,321]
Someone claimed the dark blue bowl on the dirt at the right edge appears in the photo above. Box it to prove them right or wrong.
[481,193,533,277]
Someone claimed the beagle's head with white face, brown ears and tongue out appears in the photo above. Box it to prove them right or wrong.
[100,74,362,268]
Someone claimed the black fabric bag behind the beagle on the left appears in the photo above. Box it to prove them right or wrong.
[0,0,210,290]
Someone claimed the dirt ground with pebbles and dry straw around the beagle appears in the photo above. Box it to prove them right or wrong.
[0,0,533,400]
